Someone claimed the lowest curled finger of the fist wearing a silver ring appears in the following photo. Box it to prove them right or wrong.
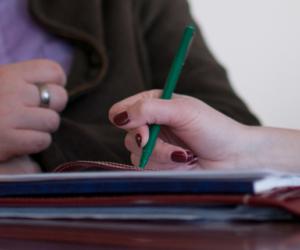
[0,130,51,160]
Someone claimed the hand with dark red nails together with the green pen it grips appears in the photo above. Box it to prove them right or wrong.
[109,24,248,170]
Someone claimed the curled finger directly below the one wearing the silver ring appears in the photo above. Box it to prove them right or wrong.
[12,108,60,133]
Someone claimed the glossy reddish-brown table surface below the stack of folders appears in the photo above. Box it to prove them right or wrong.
[0,220,300,250]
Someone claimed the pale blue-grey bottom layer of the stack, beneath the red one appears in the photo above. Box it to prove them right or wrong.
[0,206,294,221]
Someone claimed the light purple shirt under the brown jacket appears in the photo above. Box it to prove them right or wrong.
[0,0,72,72]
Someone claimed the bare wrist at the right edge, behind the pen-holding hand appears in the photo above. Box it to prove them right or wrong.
[241,127,300,171]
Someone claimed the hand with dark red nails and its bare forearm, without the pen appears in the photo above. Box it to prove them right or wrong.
[109,90,300,171]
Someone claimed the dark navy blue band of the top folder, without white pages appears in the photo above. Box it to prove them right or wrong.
[0,178,254,197]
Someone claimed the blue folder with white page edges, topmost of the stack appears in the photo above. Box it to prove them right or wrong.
[0,171,288,197]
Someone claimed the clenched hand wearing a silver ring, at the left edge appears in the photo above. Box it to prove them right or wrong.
[0,60,67,165]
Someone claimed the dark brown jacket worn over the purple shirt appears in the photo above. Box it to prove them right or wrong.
[29,0,258,171]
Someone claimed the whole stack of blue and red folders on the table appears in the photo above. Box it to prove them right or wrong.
[0,161,300,221]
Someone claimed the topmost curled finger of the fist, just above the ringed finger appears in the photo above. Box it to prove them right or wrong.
[4,59,66,86]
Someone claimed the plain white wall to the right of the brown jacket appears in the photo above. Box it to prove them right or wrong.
[190,0,300,129]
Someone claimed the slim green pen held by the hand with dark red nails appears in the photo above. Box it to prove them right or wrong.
[140,25,195,168]
